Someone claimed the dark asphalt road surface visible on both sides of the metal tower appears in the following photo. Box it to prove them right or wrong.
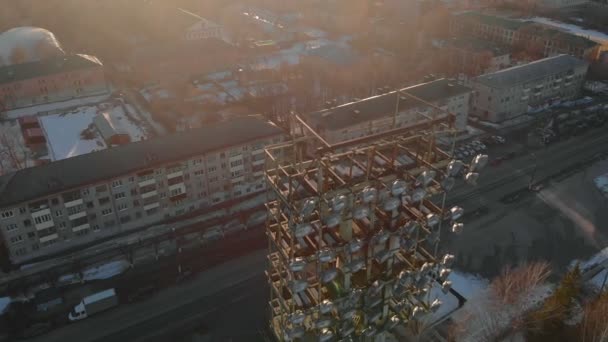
[26,127,608,342]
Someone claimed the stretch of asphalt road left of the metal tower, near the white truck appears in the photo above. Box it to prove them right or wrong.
[31,250,267,342]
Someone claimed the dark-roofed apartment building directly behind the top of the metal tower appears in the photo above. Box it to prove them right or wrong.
[304,79,471,143]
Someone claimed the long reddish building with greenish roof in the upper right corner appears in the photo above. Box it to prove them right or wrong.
[450,11,601,60]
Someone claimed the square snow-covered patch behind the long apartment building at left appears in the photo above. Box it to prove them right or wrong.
[40,106,106,161]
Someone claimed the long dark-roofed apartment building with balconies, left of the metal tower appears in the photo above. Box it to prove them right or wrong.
[0,117,282,263]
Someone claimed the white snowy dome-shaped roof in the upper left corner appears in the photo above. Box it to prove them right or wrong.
[0,27,64,65]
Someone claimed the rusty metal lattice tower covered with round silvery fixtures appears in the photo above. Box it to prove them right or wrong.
[265,89,487,341]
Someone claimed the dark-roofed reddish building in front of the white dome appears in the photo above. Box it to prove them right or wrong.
[0,54,109,112]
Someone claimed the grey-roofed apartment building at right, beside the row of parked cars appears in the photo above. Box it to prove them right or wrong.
[471,55,589,122]
